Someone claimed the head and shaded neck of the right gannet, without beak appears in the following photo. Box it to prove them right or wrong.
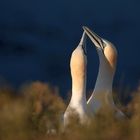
[94,39,117,94]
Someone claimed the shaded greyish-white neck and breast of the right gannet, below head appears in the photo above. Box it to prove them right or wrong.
[87,50,114,113]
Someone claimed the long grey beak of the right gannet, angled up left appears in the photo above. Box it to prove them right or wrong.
[83,26,104,50]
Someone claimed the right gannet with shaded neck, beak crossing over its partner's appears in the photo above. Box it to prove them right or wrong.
[83,26,125,118]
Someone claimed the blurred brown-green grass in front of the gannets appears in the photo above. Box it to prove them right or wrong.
[0,82,140,140]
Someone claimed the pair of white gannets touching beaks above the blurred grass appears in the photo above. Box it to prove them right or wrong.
[64,27,124,126]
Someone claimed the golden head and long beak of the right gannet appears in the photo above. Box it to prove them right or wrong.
[83,26,117,71]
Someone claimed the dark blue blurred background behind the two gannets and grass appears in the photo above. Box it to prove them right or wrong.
[0,0,140,97]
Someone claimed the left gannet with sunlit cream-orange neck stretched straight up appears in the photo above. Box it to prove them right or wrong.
[63,32,89,127]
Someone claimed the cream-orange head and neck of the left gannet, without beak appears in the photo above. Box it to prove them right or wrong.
[70,46,87,105]
